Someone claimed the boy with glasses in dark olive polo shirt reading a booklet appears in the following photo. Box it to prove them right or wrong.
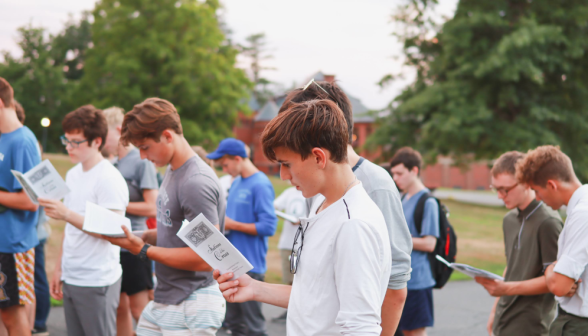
[476,151,573,336]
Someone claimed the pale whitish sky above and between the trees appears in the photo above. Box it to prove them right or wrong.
[0,0,457,109]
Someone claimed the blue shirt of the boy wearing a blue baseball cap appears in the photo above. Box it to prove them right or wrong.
[227,172,278,274]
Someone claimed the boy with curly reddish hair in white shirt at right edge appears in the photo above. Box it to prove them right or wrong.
[516,146,588,336]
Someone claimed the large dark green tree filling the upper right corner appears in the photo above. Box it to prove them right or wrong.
[370,0,588,178]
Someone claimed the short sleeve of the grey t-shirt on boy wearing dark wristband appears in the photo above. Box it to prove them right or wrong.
[178,174,221,225]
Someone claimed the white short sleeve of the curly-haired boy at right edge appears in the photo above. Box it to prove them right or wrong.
[553,211,588,281]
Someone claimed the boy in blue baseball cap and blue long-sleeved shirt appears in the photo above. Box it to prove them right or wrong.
[206,138,278,336]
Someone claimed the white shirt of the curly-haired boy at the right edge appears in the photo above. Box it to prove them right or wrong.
[553,185,588,317]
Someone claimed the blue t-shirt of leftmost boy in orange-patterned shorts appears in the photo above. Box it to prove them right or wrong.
[0,126,41,253]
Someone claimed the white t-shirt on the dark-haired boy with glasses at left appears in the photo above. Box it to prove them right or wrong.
[61,159,129,287]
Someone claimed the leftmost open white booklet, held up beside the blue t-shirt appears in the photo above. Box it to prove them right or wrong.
[11,160,69,204]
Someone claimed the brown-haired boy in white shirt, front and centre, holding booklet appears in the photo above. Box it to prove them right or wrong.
[215,100,392,336]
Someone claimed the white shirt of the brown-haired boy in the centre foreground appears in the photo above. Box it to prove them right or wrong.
[286,183,392,336]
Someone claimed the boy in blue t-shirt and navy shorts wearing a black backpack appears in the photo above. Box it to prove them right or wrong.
[390,147,439,336]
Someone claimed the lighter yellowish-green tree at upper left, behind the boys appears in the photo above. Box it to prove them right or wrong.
[77,0,250,147]
